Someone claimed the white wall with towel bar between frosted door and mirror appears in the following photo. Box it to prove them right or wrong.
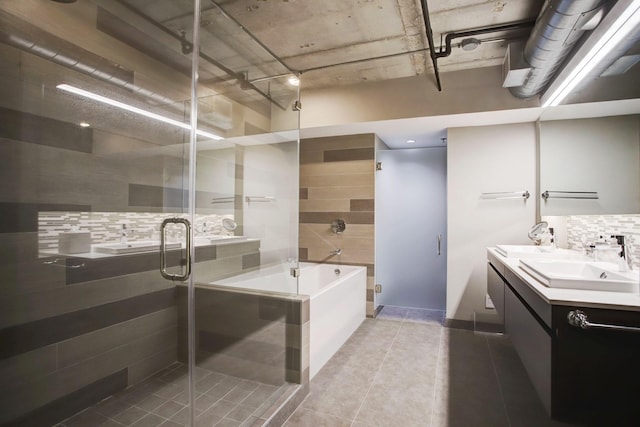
[447,123,537,322]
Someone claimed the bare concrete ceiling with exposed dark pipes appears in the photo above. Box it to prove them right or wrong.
[96,0,543,88]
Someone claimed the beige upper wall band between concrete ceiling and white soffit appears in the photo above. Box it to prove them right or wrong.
[300,66,539,129]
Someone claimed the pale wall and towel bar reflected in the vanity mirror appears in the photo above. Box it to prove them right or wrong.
[539,115,640,215]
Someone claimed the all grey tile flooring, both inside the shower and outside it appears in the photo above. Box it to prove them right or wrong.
[58,307,584,427]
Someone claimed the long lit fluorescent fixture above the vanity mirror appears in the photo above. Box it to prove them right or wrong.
[542,0,640,107]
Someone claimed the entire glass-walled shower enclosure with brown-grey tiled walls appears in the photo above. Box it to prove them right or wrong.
[0,0,308,426]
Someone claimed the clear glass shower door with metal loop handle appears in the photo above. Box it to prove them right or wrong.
[0,0,200,426]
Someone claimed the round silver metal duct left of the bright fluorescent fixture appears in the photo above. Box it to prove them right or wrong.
[509,0,606,98]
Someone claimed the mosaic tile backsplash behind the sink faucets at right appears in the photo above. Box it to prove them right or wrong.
[566,215,640,269]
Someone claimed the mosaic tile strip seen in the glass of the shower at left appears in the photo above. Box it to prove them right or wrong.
[38,211,233,251]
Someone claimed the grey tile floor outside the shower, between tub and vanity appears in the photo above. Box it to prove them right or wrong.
[284,307,567,427]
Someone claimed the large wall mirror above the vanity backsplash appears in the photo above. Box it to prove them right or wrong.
[538,51,640,216]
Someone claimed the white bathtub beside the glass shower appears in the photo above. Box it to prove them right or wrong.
[212,263,367,378]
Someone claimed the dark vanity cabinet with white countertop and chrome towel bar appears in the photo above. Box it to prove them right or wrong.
[487,248,640,425]
